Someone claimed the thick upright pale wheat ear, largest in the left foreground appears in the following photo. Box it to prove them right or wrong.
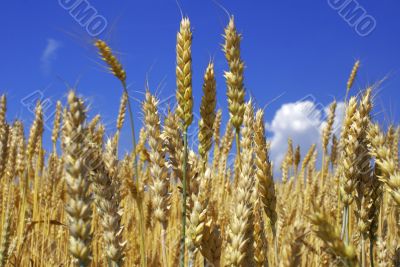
[64,91,92,266]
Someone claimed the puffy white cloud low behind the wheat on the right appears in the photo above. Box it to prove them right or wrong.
[266,100,344,178]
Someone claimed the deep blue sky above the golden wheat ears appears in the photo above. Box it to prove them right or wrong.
[0,0,400,153]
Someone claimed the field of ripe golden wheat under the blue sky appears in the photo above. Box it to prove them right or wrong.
[0,17,400,267]
